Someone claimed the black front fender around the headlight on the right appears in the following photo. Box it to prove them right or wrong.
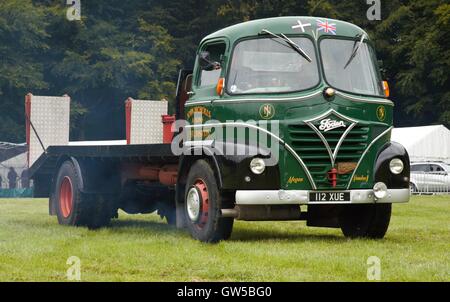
[374,142,411,189]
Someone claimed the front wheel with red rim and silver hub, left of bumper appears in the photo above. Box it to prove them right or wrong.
[184,160,234,243]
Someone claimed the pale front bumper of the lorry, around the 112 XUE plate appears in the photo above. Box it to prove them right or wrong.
[236,189,411,205]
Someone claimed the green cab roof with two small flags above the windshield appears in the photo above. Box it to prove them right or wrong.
[202,17,368,44]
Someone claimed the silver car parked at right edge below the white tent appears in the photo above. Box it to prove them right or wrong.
[410,162,450,193]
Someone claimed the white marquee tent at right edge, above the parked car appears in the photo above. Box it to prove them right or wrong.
[392,125,450,164]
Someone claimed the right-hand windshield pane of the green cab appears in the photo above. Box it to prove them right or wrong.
[320,39,384,96]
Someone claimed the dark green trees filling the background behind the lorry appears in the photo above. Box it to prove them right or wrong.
[0,0,450,142]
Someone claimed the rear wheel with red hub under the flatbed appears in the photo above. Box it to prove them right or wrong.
[54,161,111,228]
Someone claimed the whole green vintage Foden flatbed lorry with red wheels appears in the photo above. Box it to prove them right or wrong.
[28,17,410,242]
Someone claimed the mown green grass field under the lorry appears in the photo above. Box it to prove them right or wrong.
[0,196,450,281]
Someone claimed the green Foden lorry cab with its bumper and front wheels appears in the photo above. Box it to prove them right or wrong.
[179,17,410,240]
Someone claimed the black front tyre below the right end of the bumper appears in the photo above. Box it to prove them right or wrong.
[339,203,392,239]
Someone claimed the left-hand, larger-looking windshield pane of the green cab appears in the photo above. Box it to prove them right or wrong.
[227,38,319,94]
